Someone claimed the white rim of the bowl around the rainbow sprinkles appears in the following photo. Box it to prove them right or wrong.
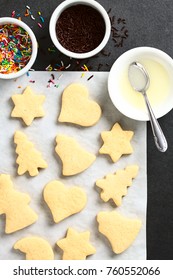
[0,17,38,79]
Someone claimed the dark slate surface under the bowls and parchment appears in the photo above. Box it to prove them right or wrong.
[0,0,173,259]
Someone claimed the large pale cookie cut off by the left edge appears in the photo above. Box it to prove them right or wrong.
[0,174,37,233]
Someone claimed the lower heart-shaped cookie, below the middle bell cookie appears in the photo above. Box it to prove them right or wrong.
[43,180,87,223]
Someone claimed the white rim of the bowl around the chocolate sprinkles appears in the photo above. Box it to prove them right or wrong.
[49,0,111,59]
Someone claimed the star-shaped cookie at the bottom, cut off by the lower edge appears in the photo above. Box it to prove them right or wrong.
[56,228,96,260]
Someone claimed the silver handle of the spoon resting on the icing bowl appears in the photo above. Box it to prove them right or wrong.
[143,92,168,152]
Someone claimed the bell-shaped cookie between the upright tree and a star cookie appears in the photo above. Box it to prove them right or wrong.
[55,135,96,176]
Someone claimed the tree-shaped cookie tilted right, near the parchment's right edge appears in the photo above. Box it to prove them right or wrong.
[96,165,139,206]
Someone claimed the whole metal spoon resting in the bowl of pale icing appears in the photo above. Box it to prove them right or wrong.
[128,61,168,152]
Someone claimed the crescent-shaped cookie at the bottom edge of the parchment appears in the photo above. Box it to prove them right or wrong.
[14,236,54,260]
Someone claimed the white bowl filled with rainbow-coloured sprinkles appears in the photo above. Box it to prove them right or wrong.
[0,17,37,79]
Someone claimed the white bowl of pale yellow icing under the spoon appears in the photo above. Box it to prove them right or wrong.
[108,47,173,121]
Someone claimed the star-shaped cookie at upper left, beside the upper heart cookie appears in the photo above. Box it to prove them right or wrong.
[11,86,45,126]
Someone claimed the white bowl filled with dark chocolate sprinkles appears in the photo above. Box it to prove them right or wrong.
[49,0,111,59]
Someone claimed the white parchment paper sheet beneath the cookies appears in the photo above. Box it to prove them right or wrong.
[0,72,147,260]
